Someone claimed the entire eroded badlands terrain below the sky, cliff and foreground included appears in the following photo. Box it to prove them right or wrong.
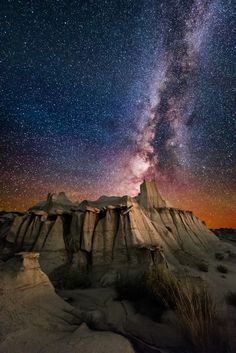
[0,181,236,353]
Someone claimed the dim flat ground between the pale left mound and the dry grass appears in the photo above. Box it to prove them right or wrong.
[59,288,183,352]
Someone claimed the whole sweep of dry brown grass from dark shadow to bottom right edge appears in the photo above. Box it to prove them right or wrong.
[147,266,229,353]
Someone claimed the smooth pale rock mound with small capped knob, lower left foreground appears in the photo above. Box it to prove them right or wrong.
[0,253,134,353]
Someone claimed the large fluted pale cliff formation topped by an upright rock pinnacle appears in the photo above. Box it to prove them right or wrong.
[0,181,219,280]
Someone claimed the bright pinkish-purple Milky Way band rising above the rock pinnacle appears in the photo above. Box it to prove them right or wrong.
[120,0,229,186]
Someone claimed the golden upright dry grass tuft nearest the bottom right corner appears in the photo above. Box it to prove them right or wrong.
[176,281,229,353]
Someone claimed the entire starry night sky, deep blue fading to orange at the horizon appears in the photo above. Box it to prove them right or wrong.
[0,0,236,227]
